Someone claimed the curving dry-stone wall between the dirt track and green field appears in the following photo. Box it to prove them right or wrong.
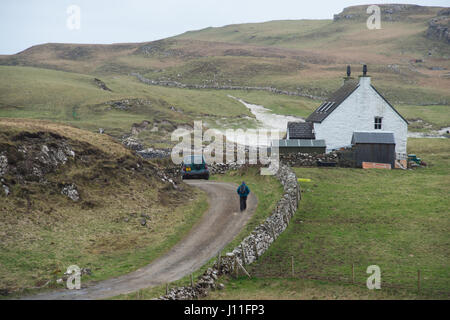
[159,165,301,300]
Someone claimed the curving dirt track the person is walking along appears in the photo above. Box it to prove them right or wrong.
[24,180,257,300]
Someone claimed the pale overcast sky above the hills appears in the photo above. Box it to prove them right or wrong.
[0,0,449,54]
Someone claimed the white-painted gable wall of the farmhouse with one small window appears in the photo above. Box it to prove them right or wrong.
[314,77,408,153]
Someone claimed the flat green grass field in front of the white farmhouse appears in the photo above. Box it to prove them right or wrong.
[208,139,450,299]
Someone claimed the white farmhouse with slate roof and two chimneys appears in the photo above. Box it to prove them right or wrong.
[306,66,408,156]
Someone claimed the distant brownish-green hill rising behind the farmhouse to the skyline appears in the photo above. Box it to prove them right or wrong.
[0,5,450,104]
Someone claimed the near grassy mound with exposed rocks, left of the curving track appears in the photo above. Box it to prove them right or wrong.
[0,119,207,295]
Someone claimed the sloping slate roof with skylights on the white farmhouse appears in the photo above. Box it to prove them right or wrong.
[306,80,359,122]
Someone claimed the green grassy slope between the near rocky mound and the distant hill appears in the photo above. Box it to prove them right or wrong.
[0,66,260,145]
